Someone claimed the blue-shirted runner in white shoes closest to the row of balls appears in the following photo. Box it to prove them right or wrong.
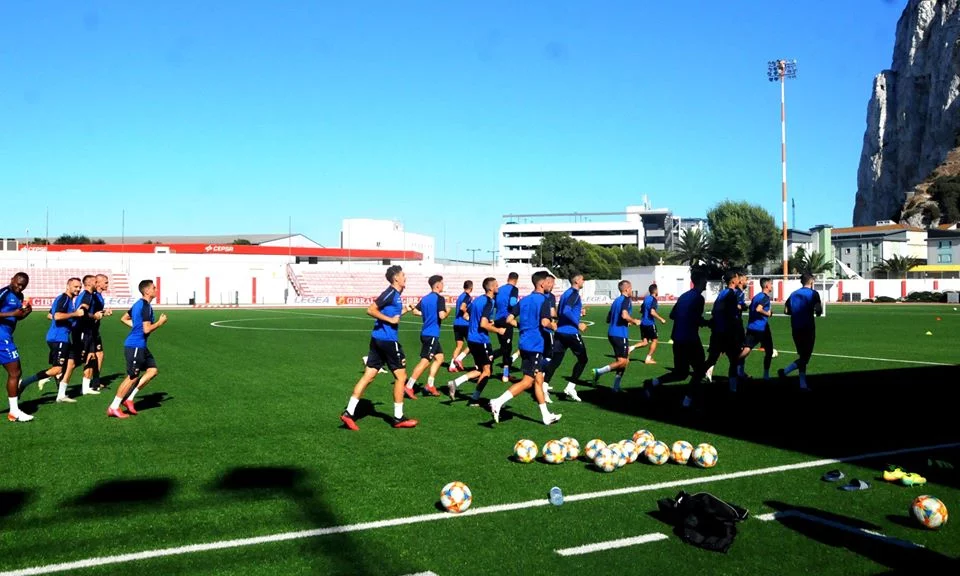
[490,271,561,426]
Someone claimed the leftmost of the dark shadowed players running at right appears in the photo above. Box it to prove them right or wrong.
[644,273,707,407]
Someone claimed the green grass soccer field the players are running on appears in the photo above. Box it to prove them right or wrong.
[0,305,960,576]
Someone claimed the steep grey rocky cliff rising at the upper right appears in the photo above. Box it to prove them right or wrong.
[853,0,960,226]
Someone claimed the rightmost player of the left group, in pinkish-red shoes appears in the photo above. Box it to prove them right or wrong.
[107,280,167,420]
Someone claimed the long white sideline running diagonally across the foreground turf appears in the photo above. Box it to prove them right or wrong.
[0,442,960,576]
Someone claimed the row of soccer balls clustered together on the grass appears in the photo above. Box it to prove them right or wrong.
[513,430,718,472]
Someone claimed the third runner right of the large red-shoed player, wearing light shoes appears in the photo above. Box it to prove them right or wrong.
[447,278,507,407]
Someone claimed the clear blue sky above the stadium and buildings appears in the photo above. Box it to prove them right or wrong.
[0,0,905,257]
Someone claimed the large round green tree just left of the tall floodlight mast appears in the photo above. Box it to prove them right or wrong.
[707,201,778,270]
